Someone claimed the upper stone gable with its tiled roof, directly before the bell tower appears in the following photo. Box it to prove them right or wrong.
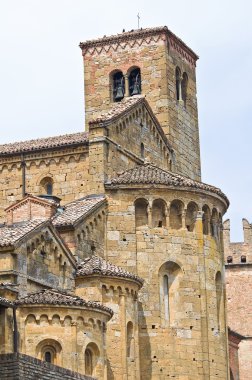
[90,96,173,177]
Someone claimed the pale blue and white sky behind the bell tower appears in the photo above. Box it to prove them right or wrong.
[0,0,252,241]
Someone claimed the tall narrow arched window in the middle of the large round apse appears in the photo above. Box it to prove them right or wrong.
[159,261,182,326]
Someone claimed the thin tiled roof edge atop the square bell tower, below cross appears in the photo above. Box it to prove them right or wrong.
[79,26,199,60]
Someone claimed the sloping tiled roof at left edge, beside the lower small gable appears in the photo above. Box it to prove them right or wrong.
[0,218,47,247]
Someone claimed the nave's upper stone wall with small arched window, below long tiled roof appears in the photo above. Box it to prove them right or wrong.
[0,146,89,222]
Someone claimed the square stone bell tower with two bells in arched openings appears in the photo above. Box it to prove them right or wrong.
[80,27,201,181]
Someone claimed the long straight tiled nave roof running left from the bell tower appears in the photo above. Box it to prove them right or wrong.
[0,132,88,156]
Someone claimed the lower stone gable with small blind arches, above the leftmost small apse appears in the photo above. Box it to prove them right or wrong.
[12,224,75,292]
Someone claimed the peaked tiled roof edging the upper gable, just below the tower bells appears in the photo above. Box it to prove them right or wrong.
[89,95,173,151]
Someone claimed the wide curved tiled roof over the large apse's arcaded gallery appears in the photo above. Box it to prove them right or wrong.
[106,164,229,204]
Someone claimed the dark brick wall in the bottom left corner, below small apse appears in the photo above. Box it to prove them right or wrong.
[0,354,94,380]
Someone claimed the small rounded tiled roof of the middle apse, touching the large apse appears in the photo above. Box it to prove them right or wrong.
[76,255,143,285]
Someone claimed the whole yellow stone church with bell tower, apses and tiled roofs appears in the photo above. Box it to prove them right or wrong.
[0,27,232,380]
